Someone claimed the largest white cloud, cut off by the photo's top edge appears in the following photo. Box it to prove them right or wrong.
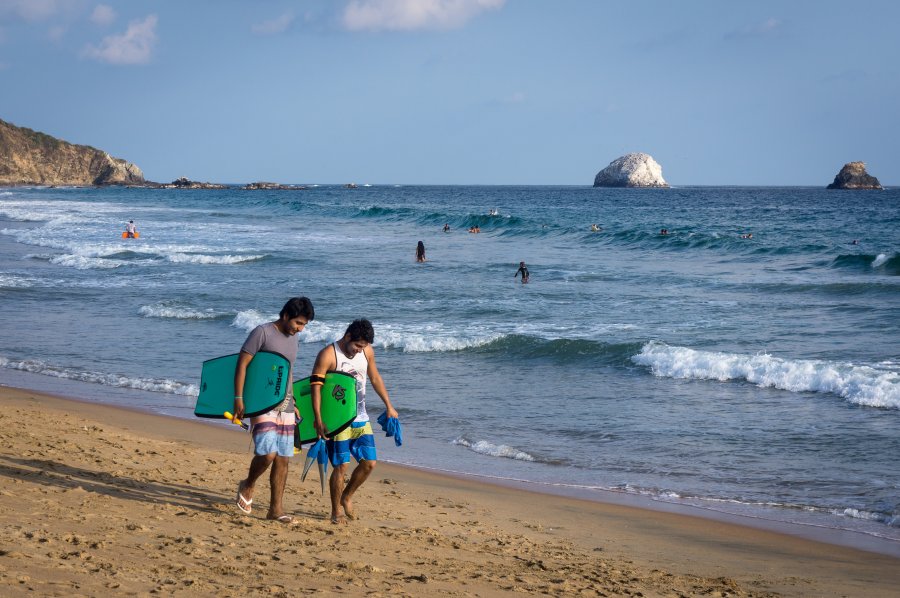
[342,0,506,31]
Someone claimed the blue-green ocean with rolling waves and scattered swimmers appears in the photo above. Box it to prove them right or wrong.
[0,185,900,546]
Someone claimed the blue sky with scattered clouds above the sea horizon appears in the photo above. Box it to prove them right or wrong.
[0,0,900,186]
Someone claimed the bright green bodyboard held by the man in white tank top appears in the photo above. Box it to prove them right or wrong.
[294,372,356,448]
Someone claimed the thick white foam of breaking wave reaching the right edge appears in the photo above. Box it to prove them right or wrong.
[631,341,900,409]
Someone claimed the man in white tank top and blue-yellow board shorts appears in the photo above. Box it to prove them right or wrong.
[310,320,398,523]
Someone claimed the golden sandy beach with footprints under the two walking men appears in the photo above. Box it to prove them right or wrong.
[0,388,900,596]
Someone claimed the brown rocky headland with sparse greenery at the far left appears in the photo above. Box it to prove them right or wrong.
[0,120,145,186]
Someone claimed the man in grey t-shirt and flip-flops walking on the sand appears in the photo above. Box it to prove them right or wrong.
[233,297,315,523]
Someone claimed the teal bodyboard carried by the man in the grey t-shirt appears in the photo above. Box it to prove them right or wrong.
[194,351,291,418]
